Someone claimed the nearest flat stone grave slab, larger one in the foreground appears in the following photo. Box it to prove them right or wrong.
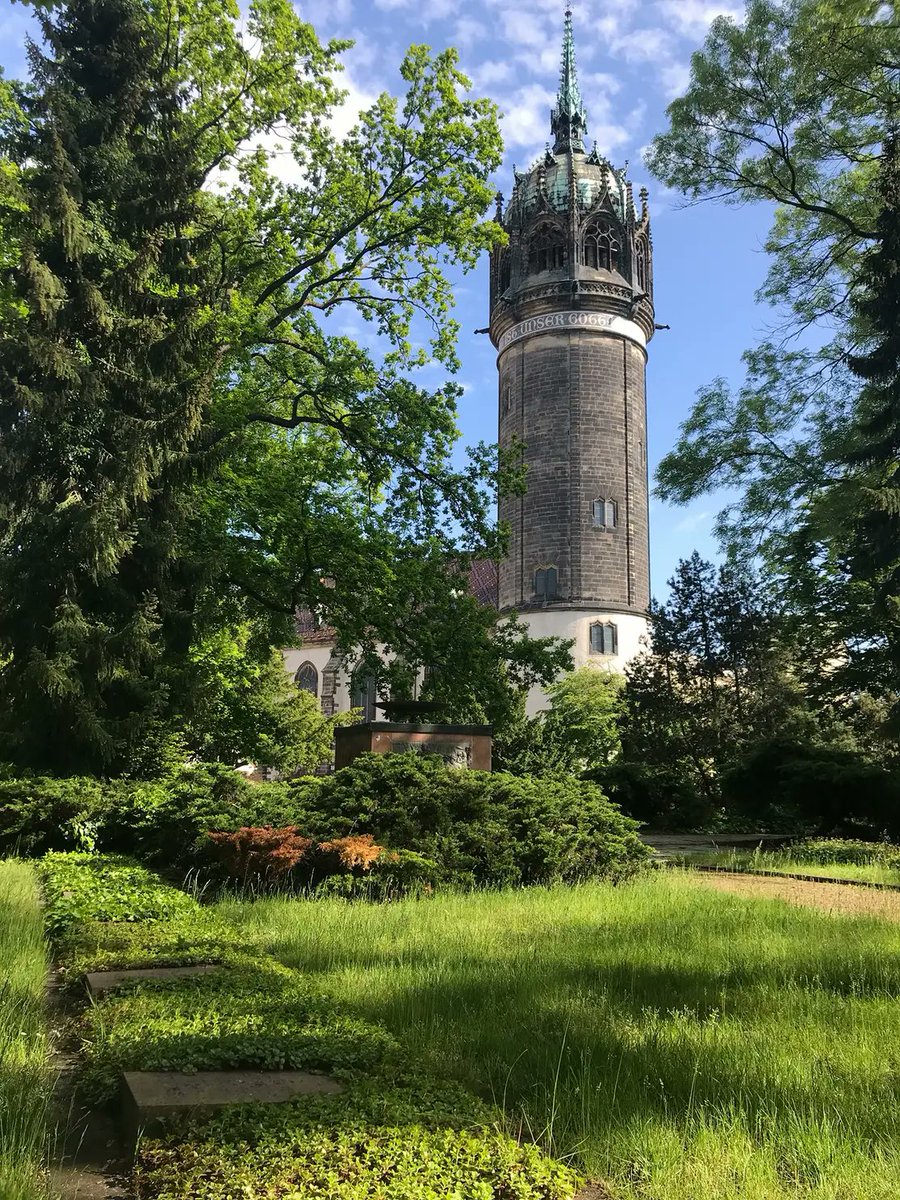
[121,1070,343,1144]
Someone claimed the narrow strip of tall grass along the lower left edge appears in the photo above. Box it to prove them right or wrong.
[0,860,49,1200]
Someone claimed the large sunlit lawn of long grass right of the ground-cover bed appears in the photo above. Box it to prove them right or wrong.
[220,874,900,1200]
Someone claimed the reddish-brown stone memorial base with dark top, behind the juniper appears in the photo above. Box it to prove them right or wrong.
[335,721,493,770]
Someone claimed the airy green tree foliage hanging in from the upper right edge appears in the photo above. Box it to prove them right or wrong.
[648,0,900,706]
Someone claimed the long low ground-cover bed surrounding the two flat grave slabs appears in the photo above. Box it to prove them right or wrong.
[44,847,581,1200]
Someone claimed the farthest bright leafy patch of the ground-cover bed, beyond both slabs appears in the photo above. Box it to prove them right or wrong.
[41,853,197,935]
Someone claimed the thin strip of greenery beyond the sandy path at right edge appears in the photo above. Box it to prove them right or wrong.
[685,838,900,886]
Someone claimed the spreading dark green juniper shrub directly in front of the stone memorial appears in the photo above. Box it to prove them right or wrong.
[292,754,647,887]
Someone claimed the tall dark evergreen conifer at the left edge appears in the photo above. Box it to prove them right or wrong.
[0,0,224,770]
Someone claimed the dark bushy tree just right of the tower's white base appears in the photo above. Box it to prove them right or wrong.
[619,553,816,828]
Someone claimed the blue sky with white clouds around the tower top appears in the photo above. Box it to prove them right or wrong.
[0,0,773,595]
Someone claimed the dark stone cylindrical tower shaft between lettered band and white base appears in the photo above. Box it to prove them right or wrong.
[498,330,650,616]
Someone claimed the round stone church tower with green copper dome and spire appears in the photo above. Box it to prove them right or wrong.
[490,11,654,696]
